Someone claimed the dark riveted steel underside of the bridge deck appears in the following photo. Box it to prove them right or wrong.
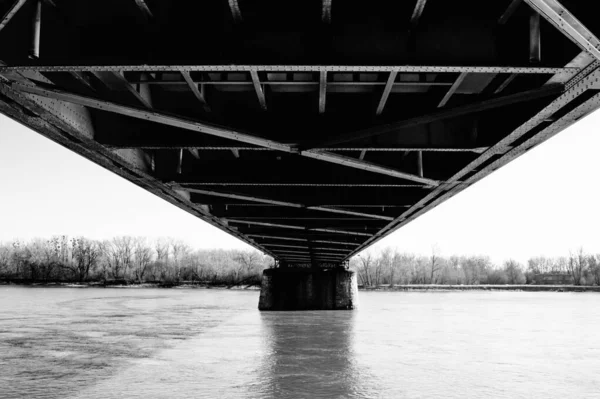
[0,0,600,266]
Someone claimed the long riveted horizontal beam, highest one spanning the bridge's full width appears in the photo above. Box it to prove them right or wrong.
[0,65,579,75]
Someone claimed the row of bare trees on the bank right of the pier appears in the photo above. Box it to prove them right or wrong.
[350,248,600,286]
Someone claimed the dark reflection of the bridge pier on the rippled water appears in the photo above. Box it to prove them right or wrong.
[260,311,359,398]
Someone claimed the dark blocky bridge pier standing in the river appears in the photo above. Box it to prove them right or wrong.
[258,267,358,310]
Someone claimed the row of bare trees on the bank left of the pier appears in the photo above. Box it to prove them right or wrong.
[0,236,273,286]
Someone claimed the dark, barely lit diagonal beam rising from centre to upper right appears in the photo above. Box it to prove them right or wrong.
[305,83,564,149]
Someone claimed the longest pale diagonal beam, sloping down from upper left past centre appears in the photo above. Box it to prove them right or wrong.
[12,82,439,186]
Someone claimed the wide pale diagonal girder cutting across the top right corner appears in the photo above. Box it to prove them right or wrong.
[523,0,600,60]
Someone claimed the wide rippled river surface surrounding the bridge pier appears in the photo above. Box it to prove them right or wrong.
[0,287,600,399]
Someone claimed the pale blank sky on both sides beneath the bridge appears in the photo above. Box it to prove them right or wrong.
[0,112,600,263]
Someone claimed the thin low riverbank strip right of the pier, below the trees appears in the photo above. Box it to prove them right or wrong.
[358,284,600,292]
